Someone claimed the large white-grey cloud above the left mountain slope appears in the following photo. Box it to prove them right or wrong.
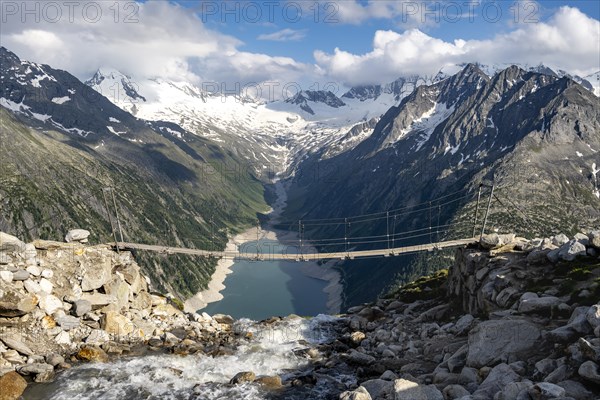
[2,1,311,84]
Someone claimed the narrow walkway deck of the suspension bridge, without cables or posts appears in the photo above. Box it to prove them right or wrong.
[117,238,479,261]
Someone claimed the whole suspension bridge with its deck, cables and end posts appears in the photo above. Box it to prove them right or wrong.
[105,184,506,261]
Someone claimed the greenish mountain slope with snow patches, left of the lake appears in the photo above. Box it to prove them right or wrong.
[0,48,267,295]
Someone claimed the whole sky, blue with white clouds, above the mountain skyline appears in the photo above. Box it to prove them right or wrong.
[0,0,600,87]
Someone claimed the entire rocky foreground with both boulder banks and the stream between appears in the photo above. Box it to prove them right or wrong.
[0,231,600,400]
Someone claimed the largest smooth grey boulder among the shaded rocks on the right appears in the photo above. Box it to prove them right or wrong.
[467,320,541,368]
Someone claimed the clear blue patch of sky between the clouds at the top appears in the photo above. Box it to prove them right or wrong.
[178,0,600,62]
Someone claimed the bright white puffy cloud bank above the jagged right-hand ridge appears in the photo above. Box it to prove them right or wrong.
[314,7,600,85]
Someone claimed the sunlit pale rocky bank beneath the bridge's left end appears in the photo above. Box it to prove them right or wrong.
[0,230,239,390]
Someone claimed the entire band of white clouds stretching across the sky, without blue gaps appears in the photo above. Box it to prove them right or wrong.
[2,0,600,94]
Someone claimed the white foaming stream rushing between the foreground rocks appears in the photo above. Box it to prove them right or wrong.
[24,315,348,400]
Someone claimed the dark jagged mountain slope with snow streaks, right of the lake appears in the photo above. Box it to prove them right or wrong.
[287,64,600,301]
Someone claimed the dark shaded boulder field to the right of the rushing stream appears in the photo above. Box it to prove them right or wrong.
[302,233,600,400]
